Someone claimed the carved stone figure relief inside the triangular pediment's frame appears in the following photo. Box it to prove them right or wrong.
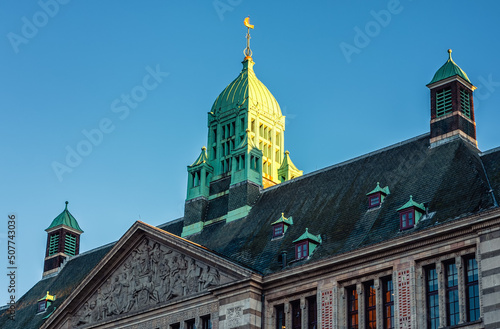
[72,238,230,328]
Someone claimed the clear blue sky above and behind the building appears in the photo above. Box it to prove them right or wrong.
[0,0,500,304]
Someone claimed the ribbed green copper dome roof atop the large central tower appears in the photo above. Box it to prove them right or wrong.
[211,58,281,117]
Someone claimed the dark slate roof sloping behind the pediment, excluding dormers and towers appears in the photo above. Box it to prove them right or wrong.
[0,134,500,329]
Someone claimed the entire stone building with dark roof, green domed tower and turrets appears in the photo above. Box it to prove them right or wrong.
[0,21,500,329]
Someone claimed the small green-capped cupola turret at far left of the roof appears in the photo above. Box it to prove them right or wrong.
[43,201,83,276]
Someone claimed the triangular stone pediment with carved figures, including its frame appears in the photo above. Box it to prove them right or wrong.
[42,222,253,328]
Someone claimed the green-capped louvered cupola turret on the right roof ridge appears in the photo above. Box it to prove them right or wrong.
[427,49,477,147]
